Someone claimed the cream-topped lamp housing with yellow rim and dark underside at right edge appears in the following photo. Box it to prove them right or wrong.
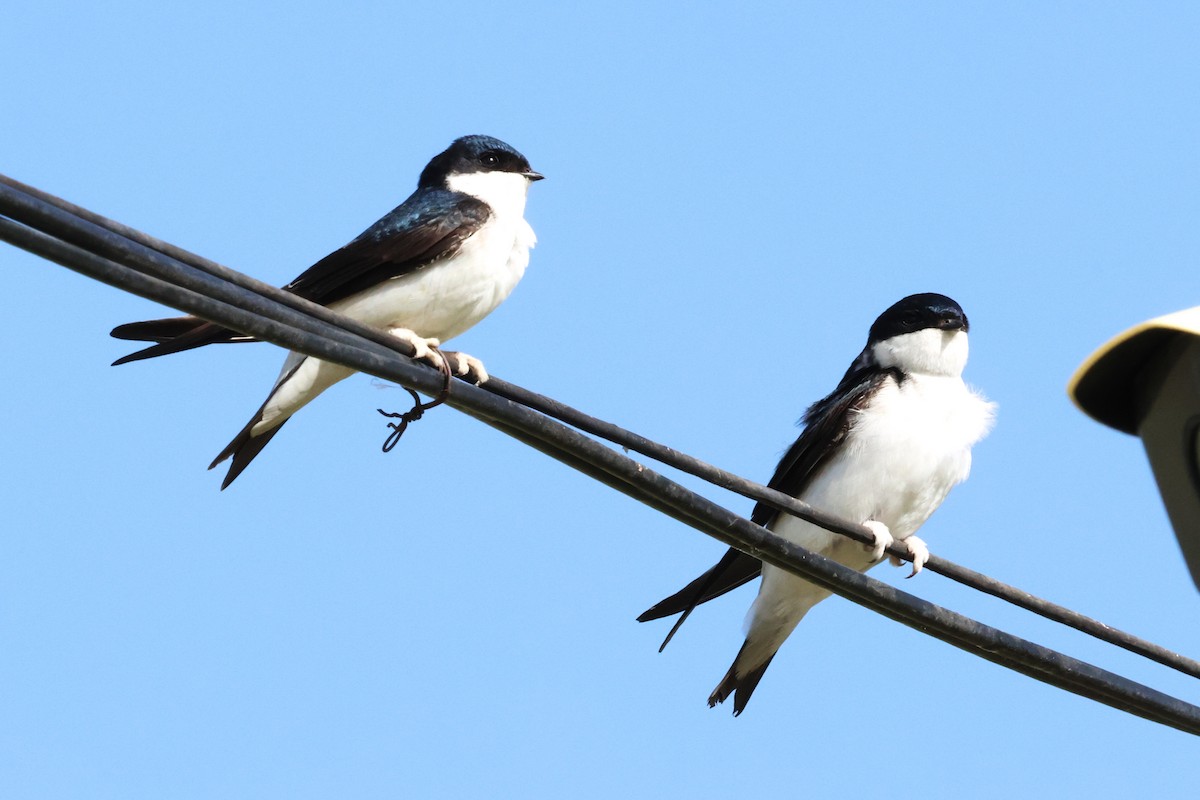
[1067,307,1200,588]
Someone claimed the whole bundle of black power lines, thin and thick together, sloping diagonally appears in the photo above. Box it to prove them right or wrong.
[0,176,1200,734]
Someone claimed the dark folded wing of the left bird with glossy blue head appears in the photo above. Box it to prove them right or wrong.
[112,190,491,365]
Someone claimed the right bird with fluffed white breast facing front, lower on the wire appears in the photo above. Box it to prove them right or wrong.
[637,294,995,715]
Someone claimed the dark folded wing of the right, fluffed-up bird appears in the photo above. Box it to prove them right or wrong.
[637,356,899,650]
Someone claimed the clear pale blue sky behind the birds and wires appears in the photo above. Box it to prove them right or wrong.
[0,1,1200,799]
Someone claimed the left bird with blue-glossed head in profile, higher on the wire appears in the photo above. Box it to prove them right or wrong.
[112,136,542,489]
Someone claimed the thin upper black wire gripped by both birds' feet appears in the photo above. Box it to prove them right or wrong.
[0,175,1200,678]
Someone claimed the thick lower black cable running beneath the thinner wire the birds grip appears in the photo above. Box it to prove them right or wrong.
[0,178,1200,734]
